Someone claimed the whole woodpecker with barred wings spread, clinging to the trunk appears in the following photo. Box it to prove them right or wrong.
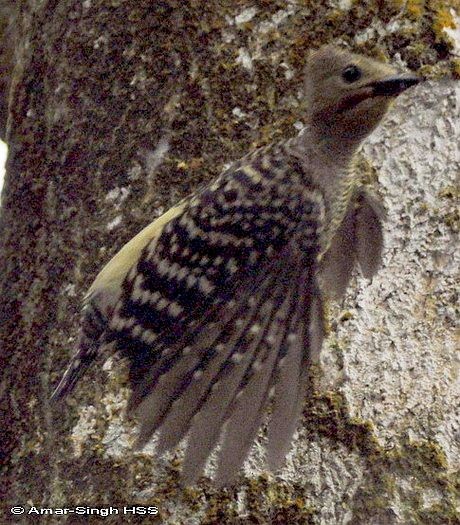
[52,45,422,486]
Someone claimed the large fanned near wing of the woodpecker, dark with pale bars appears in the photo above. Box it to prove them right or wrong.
[107,156,324,483]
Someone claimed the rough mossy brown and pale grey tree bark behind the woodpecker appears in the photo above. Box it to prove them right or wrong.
[0,0,460,525]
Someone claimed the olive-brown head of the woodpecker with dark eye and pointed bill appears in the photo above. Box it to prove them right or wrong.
[305,45,422,141]
